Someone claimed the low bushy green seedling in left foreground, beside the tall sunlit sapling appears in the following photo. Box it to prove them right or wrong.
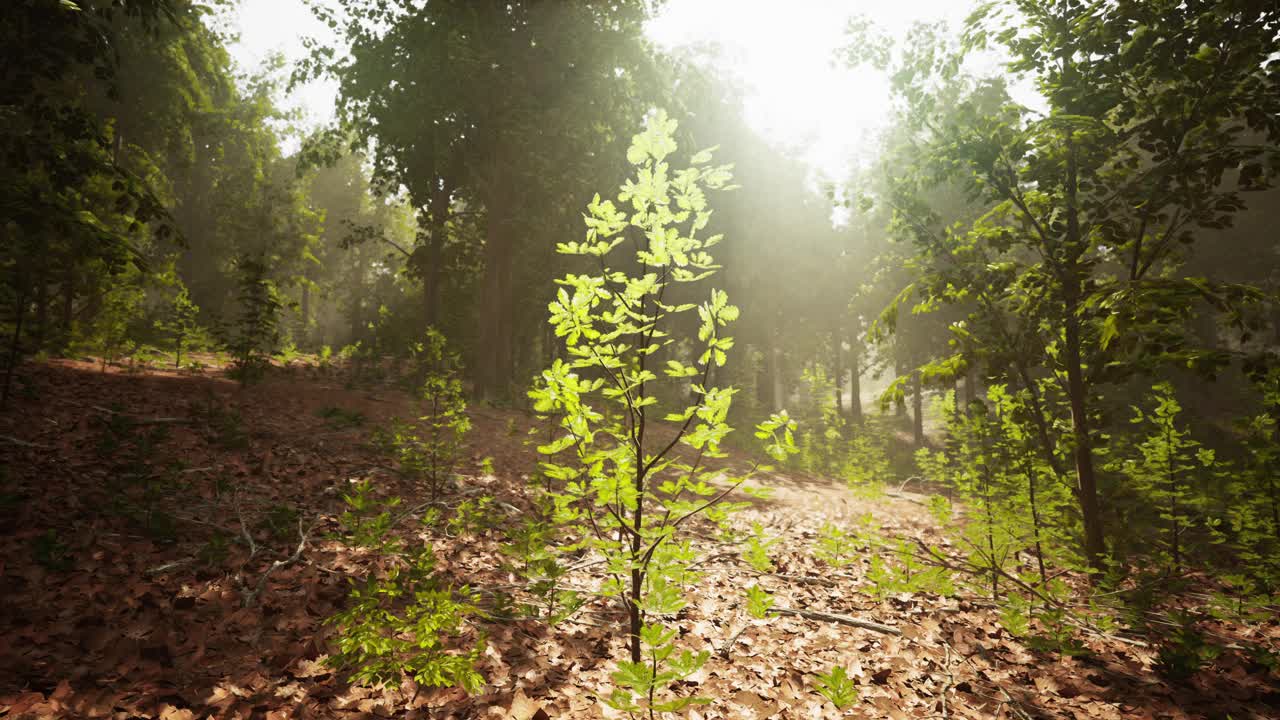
[329,546,484,693]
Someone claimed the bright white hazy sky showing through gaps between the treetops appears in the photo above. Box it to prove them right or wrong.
[232,0,974,179]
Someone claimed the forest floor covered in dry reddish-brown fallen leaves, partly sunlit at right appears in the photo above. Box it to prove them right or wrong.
[0,361,1280,720]
